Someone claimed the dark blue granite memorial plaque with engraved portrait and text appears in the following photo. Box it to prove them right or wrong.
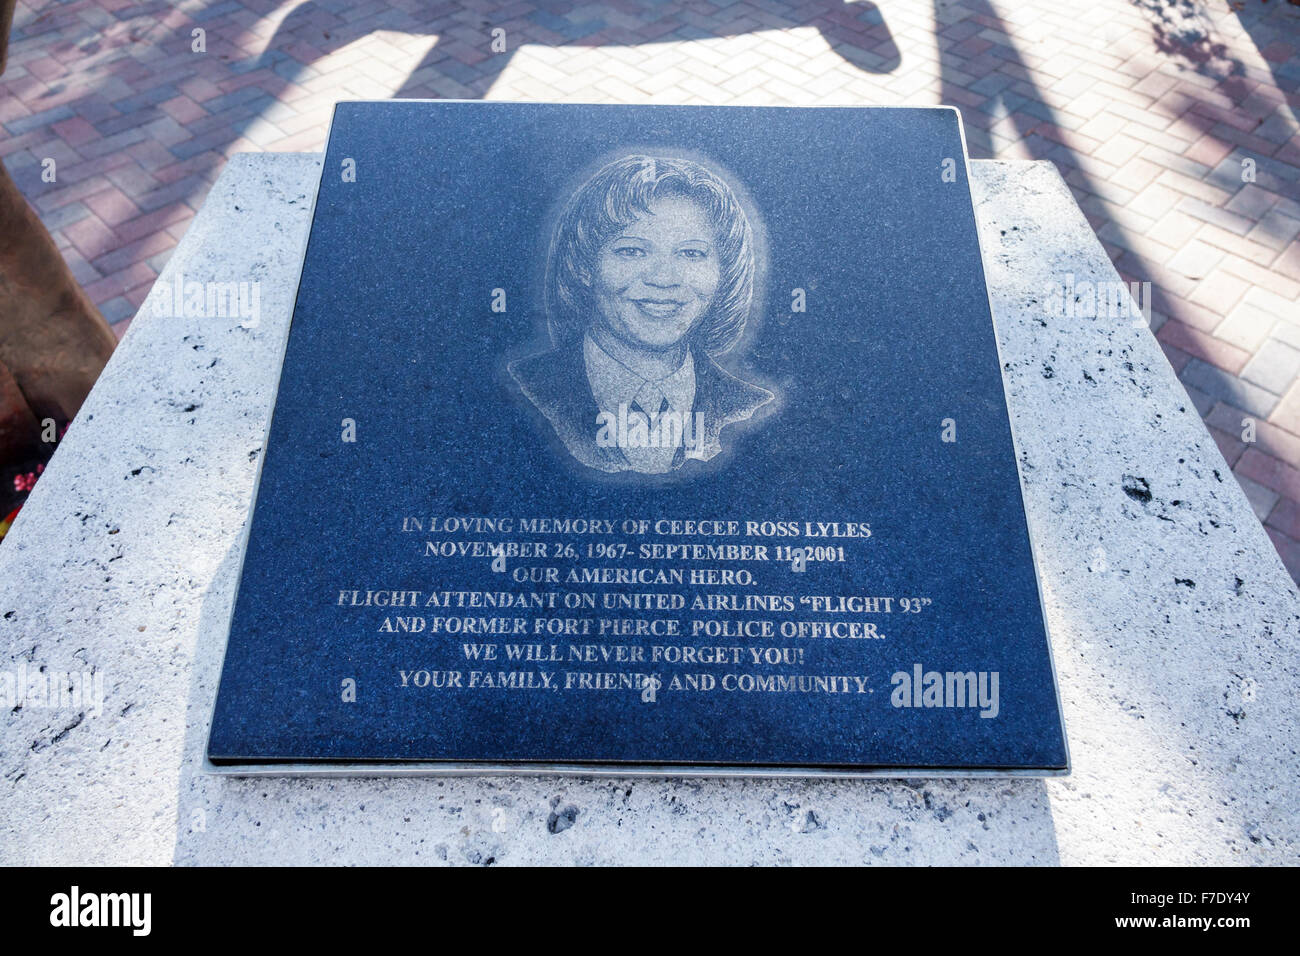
[208,101,1069,775]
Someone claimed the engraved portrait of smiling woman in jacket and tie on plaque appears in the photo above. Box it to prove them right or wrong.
[510,156,772,475]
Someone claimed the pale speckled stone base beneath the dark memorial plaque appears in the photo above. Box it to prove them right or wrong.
[0,153,1300,864]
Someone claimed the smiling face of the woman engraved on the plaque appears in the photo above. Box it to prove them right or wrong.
[594,196,719,350]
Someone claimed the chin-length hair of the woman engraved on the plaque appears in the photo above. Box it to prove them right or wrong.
[546,156,754,355]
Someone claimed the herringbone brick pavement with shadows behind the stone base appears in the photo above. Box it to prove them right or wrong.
[0,0,1300,579]
